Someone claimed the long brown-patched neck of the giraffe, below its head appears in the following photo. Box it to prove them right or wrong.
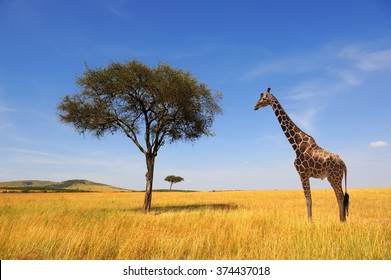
[271,96,316,155]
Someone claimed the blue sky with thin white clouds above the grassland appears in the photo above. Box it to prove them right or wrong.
[0,0,391,190]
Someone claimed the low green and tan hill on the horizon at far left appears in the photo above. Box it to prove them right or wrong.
[0,180,129,193]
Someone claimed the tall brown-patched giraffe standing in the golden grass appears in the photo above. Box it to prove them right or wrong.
[254,88,349,222]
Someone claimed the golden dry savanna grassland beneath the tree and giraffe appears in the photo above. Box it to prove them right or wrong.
[0,188,391,260]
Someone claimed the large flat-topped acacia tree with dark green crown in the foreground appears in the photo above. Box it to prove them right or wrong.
[57,60,221,212]
